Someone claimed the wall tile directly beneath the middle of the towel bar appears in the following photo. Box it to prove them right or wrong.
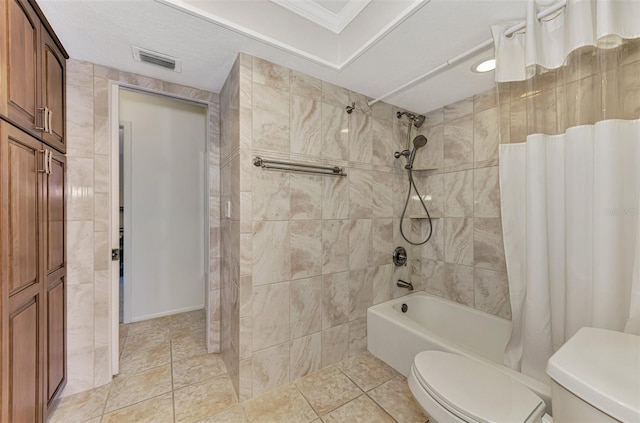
[289,174,322,220]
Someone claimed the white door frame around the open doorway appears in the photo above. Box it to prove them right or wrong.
[109,81,211,375]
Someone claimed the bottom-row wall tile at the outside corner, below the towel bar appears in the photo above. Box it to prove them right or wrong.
[252,342,289,397]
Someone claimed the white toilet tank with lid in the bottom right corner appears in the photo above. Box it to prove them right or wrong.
[547,327,640,423]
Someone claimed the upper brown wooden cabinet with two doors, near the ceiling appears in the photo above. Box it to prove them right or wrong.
[0,0,67,153]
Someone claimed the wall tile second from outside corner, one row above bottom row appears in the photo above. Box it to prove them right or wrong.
[289,277,323,338]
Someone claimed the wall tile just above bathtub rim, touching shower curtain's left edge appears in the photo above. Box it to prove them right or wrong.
[474,267,511,319]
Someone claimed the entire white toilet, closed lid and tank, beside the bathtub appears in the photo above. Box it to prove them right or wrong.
[408,328,640,423]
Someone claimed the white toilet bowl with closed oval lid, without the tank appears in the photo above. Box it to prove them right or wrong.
[414,351,544,423]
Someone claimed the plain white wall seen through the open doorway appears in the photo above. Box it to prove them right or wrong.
[119,90,208,321]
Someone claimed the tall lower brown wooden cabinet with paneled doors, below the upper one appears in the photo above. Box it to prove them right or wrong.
[0,121,66,422]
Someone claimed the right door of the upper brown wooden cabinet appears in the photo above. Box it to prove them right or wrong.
[40,28,66,153]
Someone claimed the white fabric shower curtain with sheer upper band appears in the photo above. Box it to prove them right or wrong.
[493,0,640,381]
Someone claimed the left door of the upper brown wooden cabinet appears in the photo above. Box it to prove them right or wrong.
[0,0,44,136]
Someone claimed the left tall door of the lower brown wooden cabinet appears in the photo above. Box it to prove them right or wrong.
[0,122,44,422]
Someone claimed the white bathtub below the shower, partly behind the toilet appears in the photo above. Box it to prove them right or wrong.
[367,292,551,412]
